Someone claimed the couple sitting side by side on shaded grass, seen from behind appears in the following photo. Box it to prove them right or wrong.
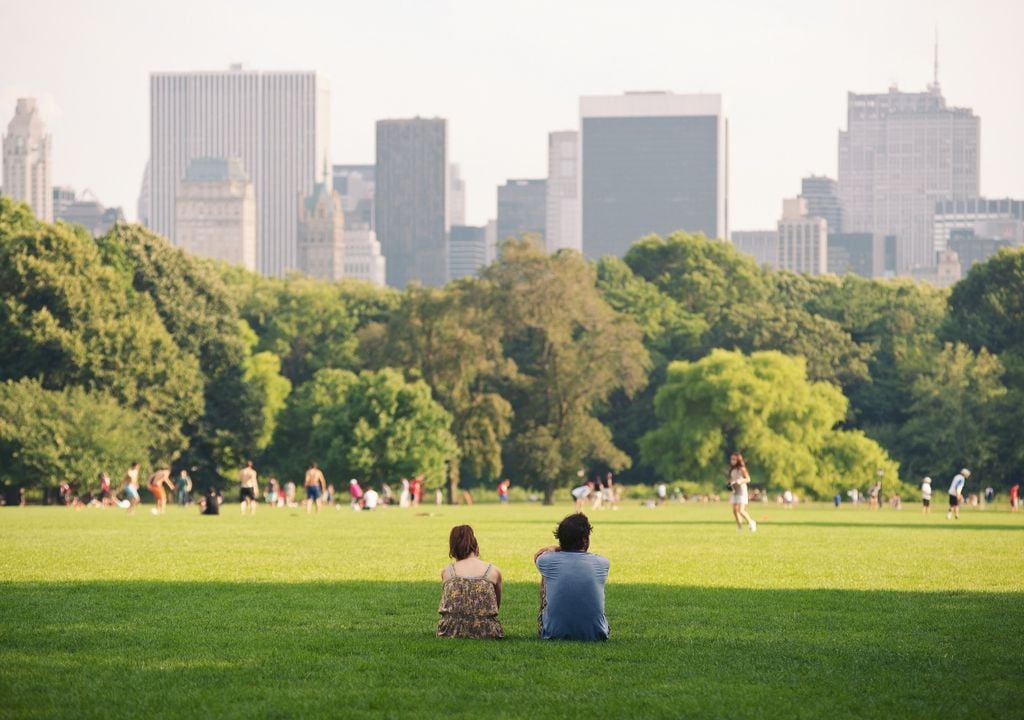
[437,512,610,640]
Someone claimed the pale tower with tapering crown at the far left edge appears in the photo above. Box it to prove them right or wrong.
[3,97,53,222]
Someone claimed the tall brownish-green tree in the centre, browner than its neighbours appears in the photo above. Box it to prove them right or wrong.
[482,241,650,503]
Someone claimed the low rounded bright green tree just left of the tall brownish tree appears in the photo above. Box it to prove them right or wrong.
[269,368,457,488]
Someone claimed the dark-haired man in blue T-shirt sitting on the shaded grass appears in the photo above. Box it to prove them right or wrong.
[534,512,609,640]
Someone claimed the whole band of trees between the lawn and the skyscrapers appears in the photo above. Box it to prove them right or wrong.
[0,194,1024,500]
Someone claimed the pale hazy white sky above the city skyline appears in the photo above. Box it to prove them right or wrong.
[0,0,1024,229]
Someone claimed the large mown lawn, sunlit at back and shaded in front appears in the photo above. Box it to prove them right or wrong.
[0,504,1024,720]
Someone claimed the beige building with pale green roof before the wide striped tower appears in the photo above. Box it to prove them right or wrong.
[174,158,256,270]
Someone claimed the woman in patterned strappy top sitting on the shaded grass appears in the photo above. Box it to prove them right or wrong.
[437,525,505,638]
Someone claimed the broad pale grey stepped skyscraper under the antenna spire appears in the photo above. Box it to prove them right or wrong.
[839,82,981,274]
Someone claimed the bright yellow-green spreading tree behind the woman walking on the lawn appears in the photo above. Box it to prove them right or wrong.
[640,350,897,496]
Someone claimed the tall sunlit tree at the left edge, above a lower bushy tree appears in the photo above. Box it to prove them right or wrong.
[0,198,203,460]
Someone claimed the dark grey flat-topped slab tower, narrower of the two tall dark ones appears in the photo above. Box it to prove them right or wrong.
[375,118,449,288]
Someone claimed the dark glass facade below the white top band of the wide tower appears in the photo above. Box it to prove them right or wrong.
[582,116,725,259]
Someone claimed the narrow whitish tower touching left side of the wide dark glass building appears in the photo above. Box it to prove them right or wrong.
[544,130,583,253]
